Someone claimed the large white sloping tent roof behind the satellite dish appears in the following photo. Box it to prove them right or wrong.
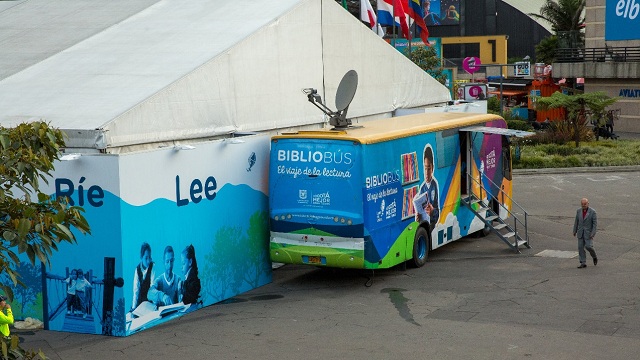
[0,0,450,152]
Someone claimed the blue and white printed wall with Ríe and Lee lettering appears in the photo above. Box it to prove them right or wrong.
[33,136,271,336]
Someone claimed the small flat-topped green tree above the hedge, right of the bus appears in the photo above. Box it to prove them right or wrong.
[536,91,618,147]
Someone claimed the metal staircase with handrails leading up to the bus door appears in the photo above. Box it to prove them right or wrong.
[461,174,531,253]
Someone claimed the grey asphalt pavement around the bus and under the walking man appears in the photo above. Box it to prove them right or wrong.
[19,167,640,360]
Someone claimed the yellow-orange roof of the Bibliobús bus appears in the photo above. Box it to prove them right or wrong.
[272,112,502,144]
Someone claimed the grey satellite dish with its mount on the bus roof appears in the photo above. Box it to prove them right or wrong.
[302,70,358,129]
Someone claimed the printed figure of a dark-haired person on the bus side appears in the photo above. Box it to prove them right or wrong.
[414,144,440,230]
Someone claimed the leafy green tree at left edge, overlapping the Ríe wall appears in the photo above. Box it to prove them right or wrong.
[0,122,90,298]
